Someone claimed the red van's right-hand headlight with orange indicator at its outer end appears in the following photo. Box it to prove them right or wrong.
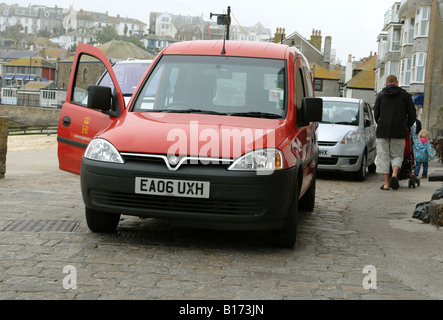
[228,149,284,171]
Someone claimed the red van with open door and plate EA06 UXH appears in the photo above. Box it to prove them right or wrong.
[58,41,322,247]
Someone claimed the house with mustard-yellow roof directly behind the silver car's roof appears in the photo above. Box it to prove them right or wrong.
[343,56,377,105]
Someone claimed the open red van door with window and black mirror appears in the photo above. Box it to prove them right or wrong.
[57,44,125,174]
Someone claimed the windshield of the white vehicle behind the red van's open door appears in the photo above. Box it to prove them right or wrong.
[98,61,150,96]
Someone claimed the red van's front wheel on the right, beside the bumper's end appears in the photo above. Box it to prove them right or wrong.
[271,185,298,248]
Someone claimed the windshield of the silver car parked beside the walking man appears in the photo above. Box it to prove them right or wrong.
[321,100,359,125]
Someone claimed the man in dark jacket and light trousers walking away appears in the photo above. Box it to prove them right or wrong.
[374,75,416,190]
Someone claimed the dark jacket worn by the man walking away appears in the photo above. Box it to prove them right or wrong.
[374,85,416,139]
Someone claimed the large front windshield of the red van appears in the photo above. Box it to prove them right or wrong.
[132,55,286,119]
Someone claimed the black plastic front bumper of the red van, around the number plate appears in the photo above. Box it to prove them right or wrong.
[80,158,297,230]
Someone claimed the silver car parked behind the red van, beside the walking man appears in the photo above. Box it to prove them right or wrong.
[318,97,376,181]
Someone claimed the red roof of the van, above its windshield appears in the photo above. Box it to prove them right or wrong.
[163,40,289,59]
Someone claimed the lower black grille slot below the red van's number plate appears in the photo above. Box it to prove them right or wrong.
[91,191,265,216]
